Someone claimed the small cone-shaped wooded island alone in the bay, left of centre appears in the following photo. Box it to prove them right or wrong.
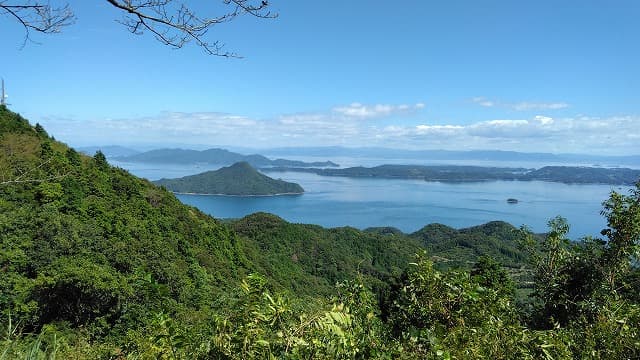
[155,162,304,195]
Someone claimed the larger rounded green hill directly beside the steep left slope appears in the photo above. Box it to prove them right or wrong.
[231,213,421,294]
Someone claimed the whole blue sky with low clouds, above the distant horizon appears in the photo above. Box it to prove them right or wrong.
[0,0,640,155]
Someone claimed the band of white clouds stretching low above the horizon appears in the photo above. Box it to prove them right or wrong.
[41,104,640,154]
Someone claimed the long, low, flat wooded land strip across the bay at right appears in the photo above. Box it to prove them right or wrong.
[269,165,640,185]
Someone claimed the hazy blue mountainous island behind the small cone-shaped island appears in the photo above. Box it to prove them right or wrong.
[113,149,339,167]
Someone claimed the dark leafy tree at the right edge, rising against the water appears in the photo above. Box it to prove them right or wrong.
[526,183,640,328]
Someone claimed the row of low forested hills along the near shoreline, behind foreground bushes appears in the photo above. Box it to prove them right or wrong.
[228,213,527,295]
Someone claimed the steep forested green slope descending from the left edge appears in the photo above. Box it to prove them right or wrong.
[0,107,251,329]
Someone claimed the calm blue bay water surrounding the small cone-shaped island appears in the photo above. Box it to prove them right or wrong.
[113,162,627,238]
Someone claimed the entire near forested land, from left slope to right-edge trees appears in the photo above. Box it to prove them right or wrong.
[0,106,640,359]
